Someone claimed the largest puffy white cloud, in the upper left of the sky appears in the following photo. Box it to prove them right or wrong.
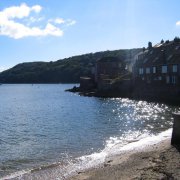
[0,3,67,39]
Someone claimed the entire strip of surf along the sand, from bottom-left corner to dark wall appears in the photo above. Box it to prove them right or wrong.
[0,129,172,180]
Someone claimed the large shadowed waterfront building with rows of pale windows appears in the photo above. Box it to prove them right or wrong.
[133,41,180,103]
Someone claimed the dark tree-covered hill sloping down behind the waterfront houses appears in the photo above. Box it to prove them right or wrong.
[0,49,141,83]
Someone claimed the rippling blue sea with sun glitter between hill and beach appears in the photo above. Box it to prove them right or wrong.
[0,84,179,178]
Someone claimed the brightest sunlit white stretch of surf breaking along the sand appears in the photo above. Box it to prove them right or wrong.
[65,129,172,177]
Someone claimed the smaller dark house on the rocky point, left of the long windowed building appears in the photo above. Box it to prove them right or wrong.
[80,57,126,91]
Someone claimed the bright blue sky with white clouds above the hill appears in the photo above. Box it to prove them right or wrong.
[0,0,180,71]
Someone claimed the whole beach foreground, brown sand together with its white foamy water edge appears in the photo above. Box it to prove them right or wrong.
[0,129,180,180]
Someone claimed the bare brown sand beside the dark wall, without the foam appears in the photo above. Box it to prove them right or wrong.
[70,138,180,180]
